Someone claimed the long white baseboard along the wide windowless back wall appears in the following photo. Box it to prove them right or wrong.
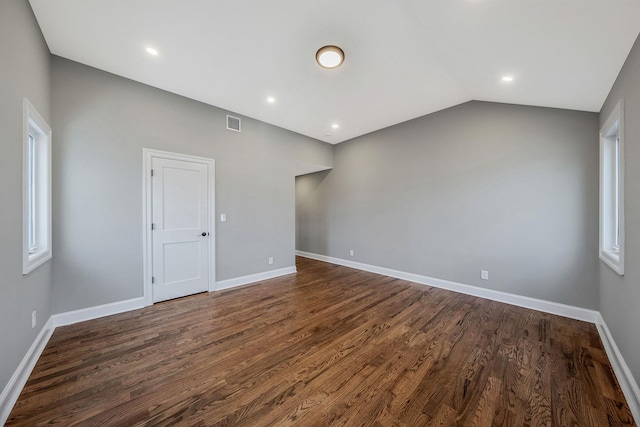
[296,251,599,323]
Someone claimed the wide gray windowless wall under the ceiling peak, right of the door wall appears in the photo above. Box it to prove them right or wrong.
[296,102,598,309]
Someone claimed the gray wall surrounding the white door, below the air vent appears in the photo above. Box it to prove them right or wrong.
[51,57,333,313]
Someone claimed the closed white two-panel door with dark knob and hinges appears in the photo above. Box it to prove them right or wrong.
[151,157,210,302]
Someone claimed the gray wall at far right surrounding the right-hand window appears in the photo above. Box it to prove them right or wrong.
[600,35,640,382]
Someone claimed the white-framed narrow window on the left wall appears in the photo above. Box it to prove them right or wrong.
[22,98,53,274]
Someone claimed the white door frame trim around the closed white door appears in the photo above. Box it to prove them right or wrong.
[142,148,216,306]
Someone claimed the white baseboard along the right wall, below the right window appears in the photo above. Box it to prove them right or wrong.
[596,313,640,423]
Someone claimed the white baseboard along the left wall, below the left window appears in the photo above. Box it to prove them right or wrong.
[0,317,55,425]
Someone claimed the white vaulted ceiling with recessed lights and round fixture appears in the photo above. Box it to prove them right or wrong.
[30,0,640,144]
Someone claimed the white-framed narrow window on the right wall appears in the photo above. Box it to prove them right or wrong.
[599,100,625,276]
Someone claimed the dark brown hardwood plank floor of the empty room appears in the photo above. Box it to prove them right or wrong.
[7,258,635,427]
